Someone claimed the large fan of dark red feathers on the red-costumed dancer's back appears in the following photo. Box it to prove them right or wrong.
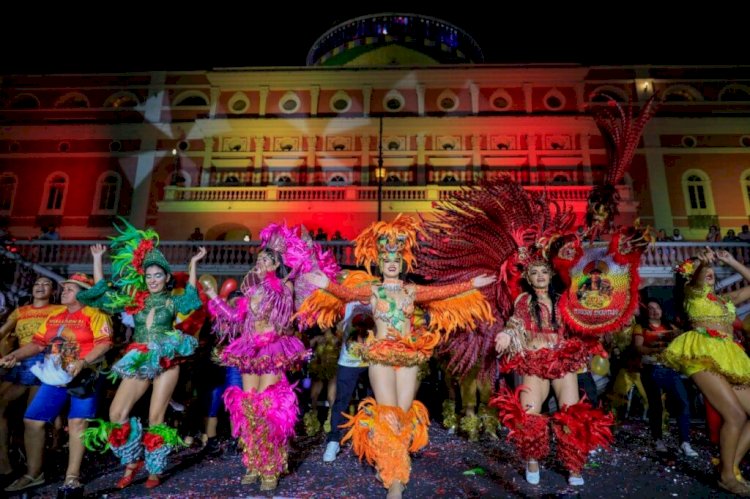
[419,177,575,320]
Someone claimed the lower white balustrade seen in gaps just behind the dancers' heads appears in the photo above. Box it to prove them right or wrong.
[8,240,750,279]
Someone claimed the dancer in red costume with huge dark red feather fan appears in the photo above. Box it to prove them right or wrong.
[422,179,613,485]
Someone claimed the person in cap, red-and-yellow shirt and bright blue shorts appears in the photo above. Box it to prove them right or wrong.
[0,274,112,495]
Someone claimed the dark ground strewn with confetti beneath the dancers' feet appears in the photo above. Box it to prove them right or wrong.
[5,420,750,499]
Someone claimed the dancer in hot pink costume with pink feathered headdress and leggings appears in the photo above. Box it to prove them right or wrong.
[206,224,337,490]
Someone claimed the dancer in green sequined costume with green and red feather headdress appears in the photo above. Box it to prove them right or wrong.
[81,219,206,488]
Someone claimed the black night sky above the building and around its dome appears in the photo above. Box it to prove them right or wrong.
[0,0,750,74]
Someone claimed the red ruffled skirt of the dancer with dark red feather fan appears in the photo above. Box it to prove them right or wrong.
[500,338,607,379]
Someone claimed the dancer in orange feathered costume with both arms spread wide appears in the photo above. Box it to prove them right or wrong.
[298,215,494,497]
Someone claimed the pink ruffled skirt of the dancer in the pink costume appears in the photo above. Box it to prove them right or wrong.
[221,331,312,375]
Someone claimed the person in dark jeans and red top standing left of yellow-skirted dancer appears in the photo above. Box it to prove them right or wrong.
[633,299,698,457]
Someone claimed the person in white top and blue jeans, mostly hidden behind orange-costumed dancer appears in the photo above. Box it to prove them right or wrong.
[323,302,375,463]
